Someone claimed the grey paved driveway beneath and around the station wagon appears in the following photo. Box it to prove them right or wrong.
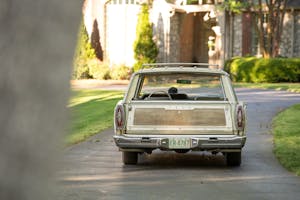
[59,89,300,200]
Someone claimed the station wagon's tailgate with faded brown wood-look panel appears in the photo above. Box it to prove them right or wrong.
[126,101,233,135]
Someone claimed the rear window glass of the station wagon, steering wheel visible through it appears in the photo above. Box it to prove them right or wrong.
[134,73,226,101]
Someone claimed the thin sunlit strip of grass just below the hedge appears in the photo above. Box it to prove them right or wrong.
[233,83,300,93]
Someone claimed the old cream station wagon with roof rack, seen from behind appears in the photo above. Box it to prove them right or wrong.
[114,63,246,166]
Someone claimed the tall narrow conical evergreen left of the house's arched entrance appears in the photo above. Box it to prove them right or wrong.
[133,4,158,71]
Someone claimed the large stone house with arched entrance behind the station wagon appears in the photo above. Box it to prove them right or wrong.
[83,0,300,66]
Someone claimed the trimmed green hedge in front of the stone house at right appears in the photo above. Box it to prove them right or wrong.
[224,57,300,83]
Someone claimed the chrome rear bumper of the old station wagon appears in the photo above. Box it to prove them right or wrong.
[114,135,246,152]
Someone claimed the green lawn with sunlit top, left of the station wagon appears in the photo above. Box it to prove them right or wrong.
[65,90,123,144]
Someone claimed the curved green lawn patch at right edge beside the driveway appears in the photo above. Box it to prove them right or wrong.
[273,104,300,176]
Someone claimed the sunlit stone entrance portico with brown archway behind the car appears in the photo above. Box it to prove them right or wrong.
[152,0,225,67]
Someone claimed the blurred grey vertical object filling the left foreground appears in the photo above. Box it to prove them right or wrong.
[0,0,81,200]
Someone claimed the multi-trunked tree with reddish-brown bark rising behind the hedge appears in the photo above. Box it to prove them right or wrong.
[221,0,287,58]
